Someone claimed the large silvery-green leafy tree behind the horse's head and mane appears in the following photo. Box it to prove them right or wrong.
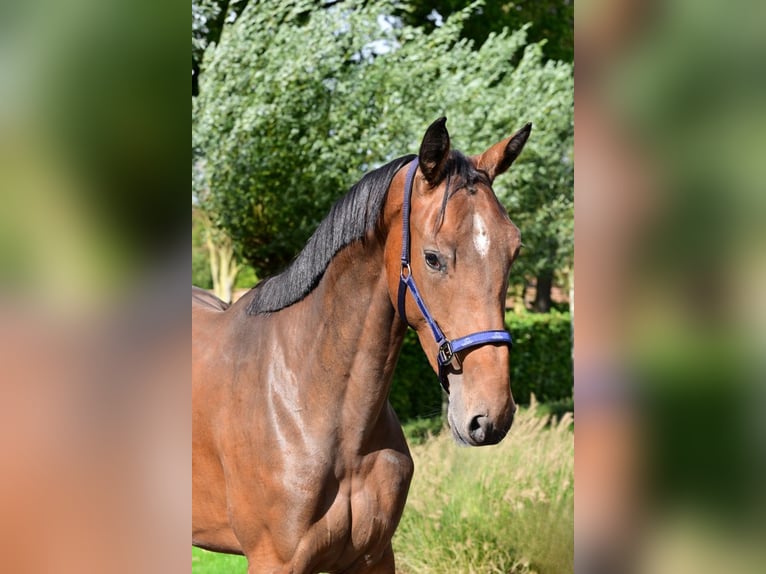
[192,0,573,290]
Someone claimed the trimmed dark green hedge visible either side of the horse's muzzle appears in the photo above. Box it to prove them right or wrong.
[390,311,573,421]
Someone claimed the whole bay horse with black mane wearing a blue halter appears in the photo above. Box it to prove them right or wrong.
[192,118,531,574]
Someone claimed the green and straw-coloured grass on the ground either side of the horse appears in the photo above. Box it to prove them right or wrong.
[192,404,574,574]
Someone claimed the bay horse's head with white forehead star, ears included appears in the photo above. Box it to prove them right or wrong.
[386,118,531,446]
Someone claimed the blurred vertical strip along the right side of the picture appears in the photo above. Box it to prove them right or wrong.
[575,0,766,573]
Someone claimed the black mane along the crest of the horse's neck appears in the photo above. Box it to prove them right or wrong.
[247,155,415,315]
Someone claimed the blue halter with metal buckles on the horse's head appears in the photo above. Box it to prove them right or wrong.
[398,158,513,393]
